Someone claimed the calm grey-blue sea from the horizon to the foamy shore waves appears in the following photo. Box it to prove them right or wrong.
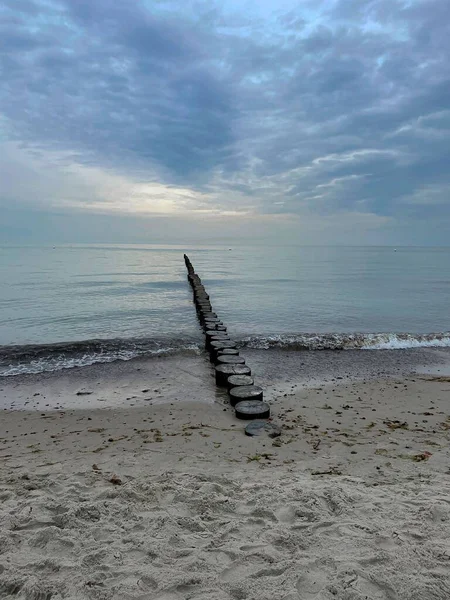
[0,244,450,376]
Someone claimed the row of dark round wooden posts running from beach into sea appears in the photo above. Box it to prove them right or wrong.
[184,254,270,419]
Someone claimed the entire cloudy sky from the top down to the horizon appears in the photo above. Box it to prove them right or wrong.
[0,0,450,245]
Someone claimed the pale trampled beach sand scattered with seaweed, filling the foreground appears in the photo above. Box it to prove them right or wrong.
[0,361,450,600]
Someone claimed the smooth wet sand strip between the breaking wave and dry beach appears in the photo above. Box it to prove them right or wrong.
[0,348,450,411]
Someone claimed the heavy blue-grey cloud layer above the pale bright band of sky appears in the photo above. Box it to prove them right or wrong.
[0,0,450,231]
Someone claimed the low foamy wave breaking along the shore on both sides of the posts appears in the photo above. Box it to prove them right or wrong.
[0,332,450,377]
